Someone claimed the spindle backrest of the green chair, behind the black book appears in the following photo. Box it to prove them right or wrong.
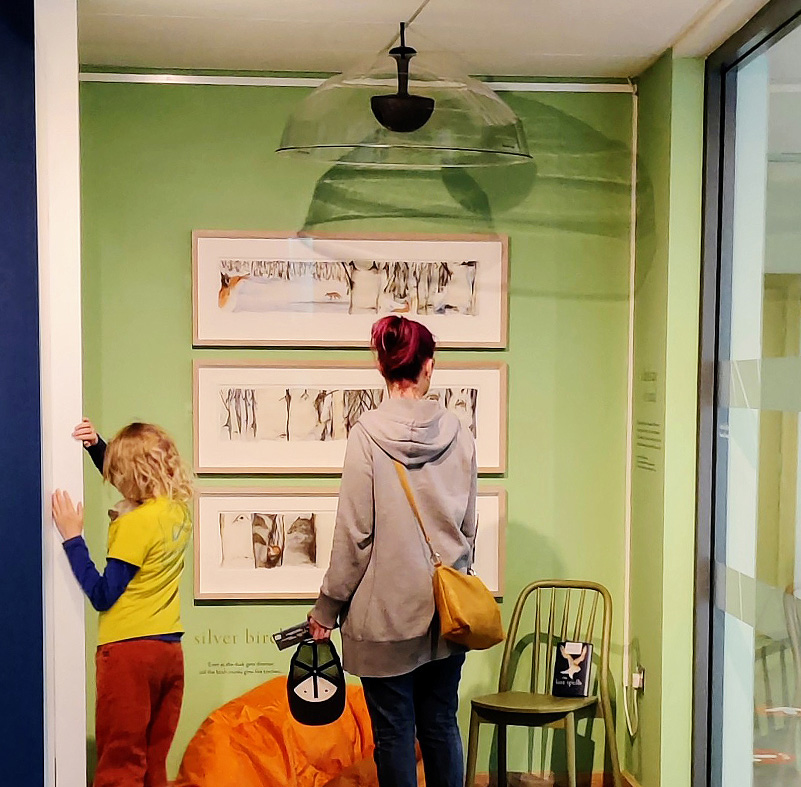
[498,579,612,695]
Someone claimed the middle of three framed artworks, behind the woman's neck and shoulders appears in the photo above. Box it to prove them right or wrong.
[194,361,506,474]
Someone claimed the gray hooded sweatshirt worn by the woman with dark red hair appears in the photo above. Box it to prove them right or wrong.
[311,398,476,677]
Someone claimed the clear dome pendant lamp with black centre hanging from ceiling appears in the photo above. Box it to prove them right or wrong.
[277,23,531,169]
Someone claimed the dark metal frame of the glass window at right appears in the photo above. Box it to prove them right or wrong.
[692,0,801,787]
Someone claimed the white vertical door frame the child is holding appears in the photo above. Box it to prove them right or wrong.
[34,0,86,787]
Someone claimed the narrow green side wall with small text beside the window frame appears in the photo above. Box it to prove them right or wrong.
[626,53,704,787]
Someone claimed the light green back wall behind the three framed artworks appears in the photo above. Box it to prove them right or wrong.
[81,84,631,772]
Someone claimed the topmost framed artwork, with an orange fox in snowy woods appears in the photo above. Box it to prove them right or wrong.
[192,230,508,348]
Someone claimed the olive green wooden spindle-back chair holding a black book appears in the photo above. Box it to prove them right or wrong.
[465,580,622,787]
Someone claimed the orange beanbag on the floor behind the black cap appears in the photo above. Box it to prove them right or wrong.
[174,677,374,787]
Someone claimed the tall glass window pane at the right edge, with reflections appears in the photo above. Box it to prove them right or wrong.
[711,21,801,787]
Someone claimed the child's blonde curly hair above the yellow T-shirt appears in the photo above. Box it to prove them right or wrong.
[103,422,192,503]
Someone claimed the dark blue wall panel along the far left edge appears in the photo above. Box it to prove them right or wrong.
[0,0,44,787]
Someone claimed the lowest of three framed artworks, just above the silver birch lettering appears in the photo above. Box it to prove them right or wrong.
[194,488,506,600]
